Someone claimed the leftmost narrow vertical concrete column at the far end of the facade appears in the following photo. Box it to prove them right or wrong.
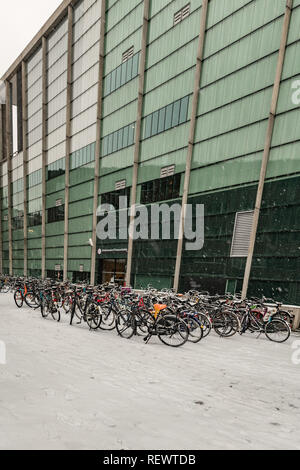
[5,81,13,276]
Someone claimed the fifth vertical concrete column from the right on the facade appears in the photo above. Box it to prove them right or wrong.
[64,5,73,281]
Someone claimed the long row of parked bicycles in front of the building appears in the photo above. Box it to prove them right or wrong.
[0,277,293,347]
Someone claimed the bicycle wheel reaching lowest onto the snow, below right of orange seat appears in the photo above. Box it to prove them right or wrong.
[155,315,189,348]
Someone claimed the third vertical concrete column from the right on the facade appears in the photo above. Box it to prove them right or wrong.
[126,0,150,286]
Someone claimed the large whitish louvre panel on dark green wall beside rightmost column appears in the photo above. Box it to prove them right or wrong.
[230,211,254,258]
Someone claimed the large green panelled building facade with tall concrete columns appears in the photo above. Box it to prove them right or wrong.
[0,0,300,303]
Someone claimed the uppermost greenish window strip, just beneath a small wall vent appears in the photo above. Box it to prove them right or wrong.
[104,48,140,96]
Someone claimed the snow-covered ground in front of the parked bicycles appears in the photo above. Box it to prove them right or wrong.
[0,294,300,450]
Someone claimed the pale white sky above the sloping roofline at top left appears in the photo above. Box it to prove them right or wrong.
[0,0,62,77]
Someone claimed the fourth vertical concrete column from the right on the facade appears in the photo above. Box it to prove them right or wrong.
[90,0,106,285]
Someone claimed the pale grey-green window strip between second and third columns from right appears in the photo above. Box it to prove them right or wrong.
[143,96,190,139]
